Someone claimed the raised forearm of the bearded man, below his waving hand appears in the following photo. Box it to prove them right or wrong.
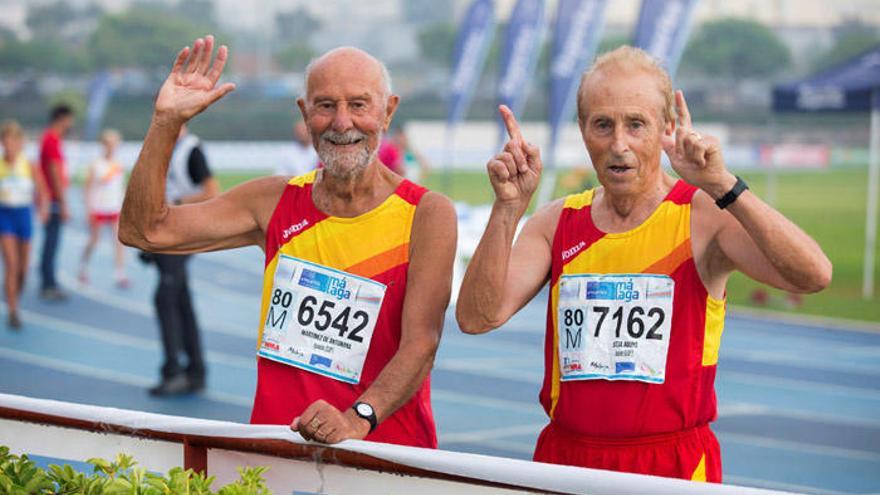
[119,116,182,250]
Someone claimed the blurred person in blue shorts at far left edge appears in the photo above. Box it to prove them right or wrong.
[0,120,49,330]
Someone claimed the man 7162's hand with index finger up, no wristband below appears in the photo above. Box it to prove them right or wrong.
[486,105,543,211]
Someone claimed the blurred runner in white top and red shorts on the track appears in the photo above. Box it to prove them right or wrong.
[79,129,129,289]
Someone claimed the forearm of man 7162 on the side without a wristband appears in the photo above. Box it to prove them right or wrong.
[455,204,522,334]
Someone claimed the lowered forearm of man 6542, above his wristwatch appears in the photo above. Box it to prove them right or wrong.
[358,336,439,423]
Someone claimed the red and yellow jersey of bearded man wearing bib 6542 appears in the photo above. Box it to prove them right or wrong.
[251,171,437,448]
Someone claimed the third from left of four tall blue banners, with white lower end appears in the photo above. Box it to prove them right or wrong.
[538,0,607,205]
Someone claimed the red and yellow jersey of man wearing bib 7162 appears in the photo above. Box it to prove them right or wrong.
[540,181,725,437]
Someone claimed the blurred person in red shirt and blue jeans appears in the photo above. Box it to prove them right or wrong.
[40,104,73,301]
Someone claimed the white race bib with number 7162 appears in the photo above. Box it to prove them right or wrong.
[556,274,675,383]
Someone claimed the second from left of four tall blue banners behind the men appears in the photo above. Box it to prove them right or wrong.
[498,0,544,142]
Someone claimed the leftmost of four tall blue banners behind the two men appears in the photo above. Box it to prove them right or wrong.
[446,0,495,126]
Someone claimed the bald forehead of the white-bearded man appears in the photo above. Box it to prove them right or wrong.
[306,51,385,101]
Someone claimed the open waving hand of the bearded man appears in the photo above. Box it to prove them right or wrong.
[155,35,235,122]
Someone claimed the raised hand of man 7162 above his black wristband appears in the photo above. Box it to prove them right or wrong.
[663,90,736,198]
